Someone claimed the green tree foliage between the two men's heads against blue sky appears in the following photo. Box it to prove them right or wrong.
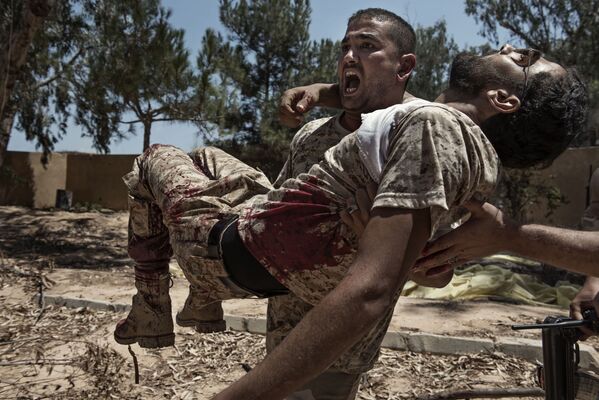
[408,20,459,101]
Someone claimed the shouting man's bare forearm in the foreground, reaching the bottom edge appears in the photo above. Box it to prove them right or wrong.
[215,276,394,400]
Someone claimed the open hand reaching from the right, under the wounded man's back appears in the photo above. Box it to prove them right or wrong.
[414,200,514,270]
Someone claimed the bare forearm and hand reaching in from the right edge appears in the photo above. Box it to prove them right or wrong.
[417,202,599,276]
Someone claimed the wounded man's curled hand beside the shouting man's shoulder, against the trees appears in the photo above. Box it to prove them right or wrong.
[279,84,320,128]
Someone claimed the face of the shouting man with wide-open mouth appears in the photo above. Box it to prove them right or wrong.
[337,20,403,113]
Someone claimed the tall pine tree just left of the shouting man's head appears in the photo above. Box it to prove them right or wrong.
[196,0,338,178]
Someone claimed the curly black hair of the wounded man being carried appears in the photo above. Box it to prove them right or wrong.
[481,68,587,168]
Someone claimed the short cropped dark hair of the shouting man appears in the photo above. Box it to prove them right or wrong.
[347,8,416,55]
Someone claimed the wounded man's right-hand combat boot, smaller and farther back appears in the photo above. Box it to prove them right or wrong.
[176,285,227,333]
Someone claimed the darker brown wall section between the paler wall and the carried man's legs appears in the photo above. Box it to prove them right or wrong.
[66,153,137,210]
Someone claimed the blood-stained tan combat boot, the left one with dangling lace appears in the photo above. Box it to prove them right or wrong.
[114,270,175,348]
